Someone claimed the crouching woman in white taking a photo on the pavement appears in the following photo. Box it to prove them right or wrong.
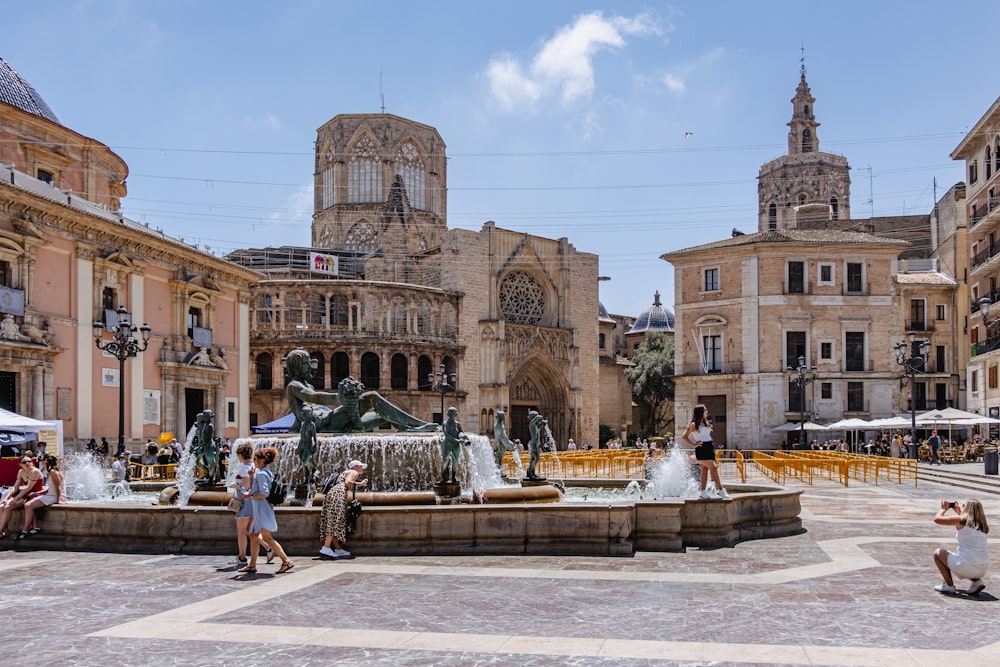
[934,500,990,595]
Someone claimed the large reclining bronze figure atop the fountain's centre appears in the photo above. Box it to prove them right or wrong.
[285,348,440,433]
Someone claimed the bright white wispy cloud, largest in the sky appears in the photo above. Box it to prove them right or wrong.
[486,12,661,110]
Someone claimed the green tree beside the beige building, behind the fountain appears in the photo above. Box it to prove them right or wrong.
[625,332,674,437]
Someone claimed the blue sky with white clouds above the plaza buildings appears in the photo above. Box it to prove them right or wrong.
[0,0,1000,316]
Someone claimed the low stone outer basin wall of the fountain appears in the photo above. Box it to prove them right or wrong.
[3,485,802,556]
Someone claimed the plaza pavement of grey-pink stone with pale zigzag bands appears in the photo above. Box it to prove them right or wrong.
[0,464,1000,667]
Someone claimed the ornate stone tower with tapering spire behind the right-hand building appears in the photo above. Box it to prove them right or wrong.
[757,65,851,232]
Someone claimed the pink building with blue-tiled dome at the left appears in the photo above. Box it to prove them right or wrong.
[0,59,260,445]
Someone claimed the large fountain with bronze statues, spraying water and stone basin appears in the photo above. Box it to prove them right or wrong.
[0,353,801,556]
